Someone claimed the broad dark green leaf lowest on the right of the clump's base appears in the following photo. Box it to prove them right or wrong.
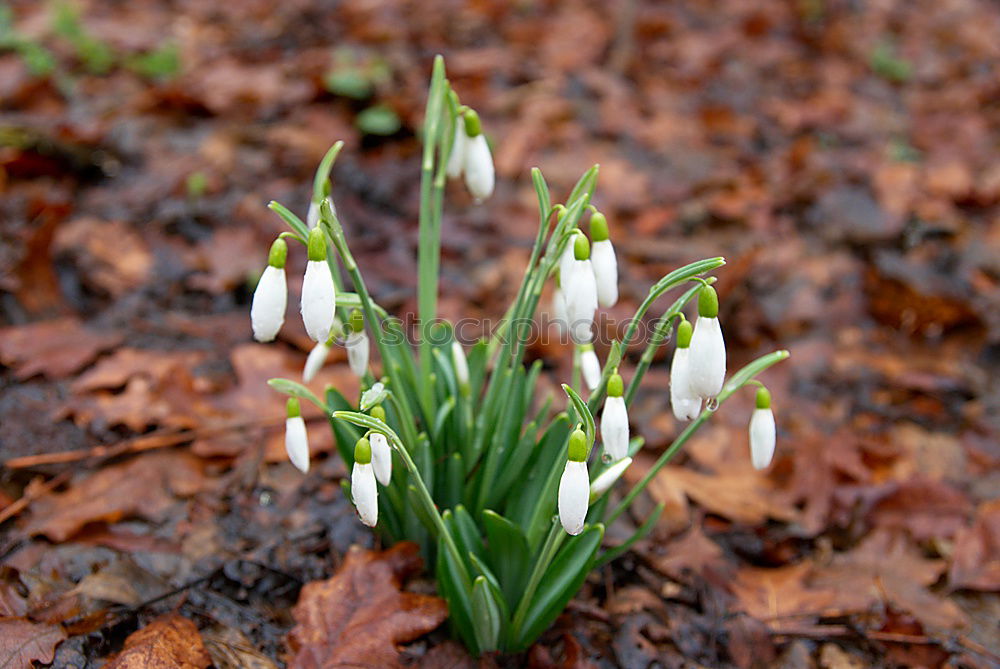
[513,524,604,651]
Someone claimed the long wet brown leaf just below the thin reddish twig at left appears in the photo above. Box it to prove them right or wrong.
[25,451,205,541]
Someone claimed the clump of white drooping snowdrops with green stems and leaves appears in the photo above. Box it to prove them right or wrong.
[251,57,788,654]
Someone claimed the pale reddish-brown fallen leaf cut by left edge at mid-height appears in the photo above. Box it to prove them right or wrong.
[0,318,122,380]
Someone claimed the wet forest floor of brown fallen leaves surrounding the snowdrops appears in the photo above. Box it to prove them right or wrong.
[0,0,1000,669]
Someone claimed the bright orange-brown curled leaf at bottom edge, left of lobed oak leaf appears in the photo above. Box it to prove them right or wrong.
[105,614,212,669]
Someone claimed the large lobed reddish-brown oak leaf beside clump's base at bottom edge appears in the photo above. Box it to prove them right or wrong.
[288,542,448,669]
